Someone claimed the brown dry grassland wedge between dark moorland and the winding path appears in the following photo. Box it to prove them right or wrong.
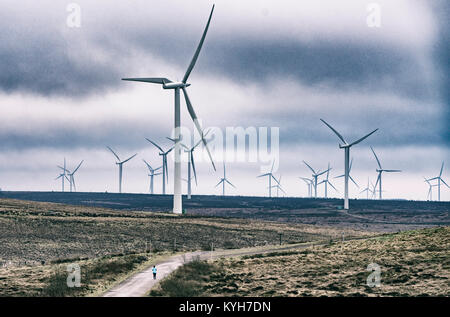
[0,199,368,266]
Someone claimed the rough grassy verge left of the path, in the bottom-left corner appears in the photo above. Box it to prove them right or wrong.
[0,249,169,297]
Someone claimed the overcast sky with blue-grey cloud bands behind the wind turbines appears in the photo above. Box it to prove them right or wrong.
[0,0,450,200]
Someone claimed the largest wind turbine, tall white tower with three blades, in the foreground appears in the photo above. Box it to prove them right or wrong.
[123,5,216,214]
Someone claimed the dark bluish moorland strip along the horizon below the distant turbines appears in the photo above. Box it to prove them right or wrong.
[0,192,450,232]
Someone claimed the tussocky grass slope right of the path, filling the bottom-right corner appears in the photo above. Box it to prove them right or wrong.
[150,227,450,297]
